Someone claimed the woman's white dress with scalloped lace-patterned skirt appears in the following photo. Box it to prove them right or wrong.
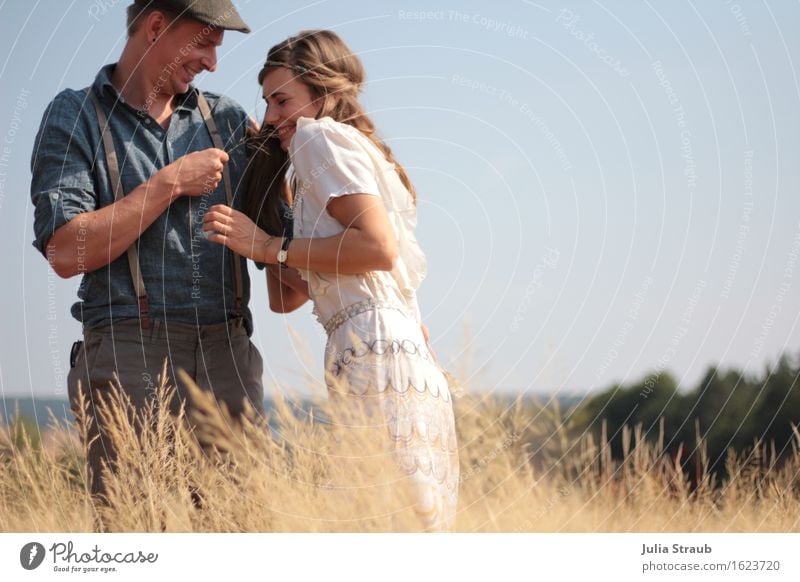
[289,117,459,531]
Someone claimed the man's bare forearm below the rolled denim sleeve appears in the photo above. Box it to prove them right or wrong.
[47,175,172,278]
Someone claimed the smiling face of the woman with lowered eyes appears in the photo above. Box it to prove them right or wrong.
[261,67,321,151]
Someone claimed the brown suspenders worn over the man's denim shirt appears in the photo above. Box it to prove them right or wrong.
[86,87,244,329]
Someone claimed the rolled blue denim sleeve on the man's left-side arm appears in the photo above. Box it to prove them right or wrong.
[31,91,97,256]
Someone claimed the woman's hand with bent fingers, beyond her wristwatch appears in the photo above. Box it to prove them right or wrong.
[203,204,280,264]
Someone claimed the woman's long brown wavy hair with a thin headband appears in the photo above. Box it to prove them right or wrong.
[244,30,416,233]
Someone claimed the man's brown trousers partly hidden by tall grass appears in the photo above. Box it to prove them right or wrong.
[67,319,264,502]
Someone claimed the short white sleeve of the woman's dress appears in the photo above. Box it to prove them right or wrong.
[289,118,381,207]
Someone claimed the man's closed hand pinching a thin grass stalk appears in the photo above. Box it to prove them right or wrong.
[155,148,228,200]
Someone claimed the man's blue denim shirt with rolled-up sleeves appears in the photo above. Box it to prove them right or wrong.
[31,64,252,329]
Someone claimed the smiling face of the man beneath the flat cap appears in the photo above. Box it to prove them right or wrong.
[150,18,224,95]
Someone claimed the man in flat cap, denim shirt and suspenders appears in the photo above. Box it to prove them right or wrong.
[31,0,263,501]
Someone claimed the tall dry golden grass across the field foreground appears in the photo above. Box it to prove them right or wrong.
[0,374,800,532]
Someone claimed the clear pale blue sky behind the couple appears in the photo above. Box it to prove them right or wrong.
[0,0,800,396]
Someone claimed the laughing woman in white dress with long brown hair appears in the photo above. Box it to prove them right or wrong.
[204,30,459,530]
